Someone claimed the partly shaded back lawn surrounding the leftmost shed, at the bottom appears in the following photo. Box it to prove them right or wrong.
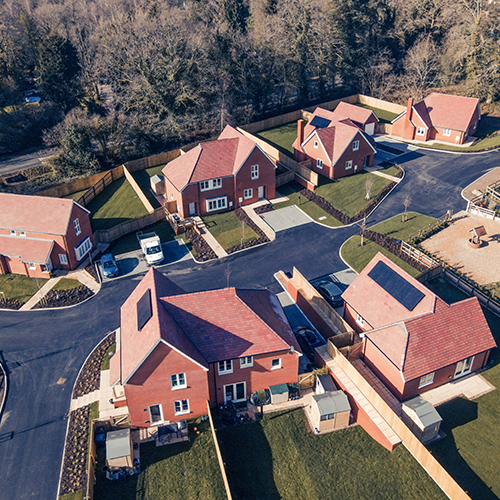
[94,422,225,500]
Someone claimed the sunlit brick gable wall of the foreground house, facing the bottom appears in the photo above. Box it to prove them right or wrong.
[125,343,208,427]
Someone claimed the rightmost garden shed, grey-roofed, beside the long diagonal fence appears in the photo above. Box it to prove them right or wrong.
[401,396,442,444]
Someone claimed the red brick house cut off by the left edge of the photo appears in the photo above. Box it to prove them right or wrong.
[0,193,93,277]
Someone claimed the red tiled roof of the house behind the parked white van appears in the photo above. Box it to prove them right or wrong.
[162,125,258,191]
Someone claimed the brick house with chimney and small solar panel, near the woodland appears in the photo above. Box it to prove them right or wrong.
[293,106,376,179]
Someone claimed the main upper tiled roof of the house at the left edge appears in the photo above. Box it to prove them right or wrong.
[0,193,87,234]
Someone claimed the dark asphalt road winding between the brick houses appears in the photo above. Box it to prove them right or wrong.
[0,143,500,500]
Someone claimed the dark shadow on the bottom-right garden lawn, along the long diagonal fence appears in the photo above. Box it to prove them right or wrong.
[429,398,498,500]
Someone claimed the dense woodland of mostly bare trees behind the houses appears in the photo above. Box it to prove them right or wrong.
[0,0,500,177]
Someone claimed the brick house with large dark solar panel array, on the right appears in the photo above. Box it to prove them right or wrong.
[343,253,496,400]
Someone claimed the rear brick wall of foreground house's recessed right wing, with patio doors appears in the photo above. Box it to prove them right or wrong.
[208,351,299,405]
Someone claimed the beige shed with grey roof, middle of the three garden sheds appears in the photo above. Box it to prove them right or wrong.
[311,391,351,432]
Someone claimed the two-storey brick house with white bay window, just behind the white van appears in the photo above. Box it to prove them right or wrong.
[162,125,276,218]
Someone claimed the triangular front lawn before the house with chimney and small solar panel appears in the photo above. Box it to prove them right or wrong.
[315,171,391,217]
